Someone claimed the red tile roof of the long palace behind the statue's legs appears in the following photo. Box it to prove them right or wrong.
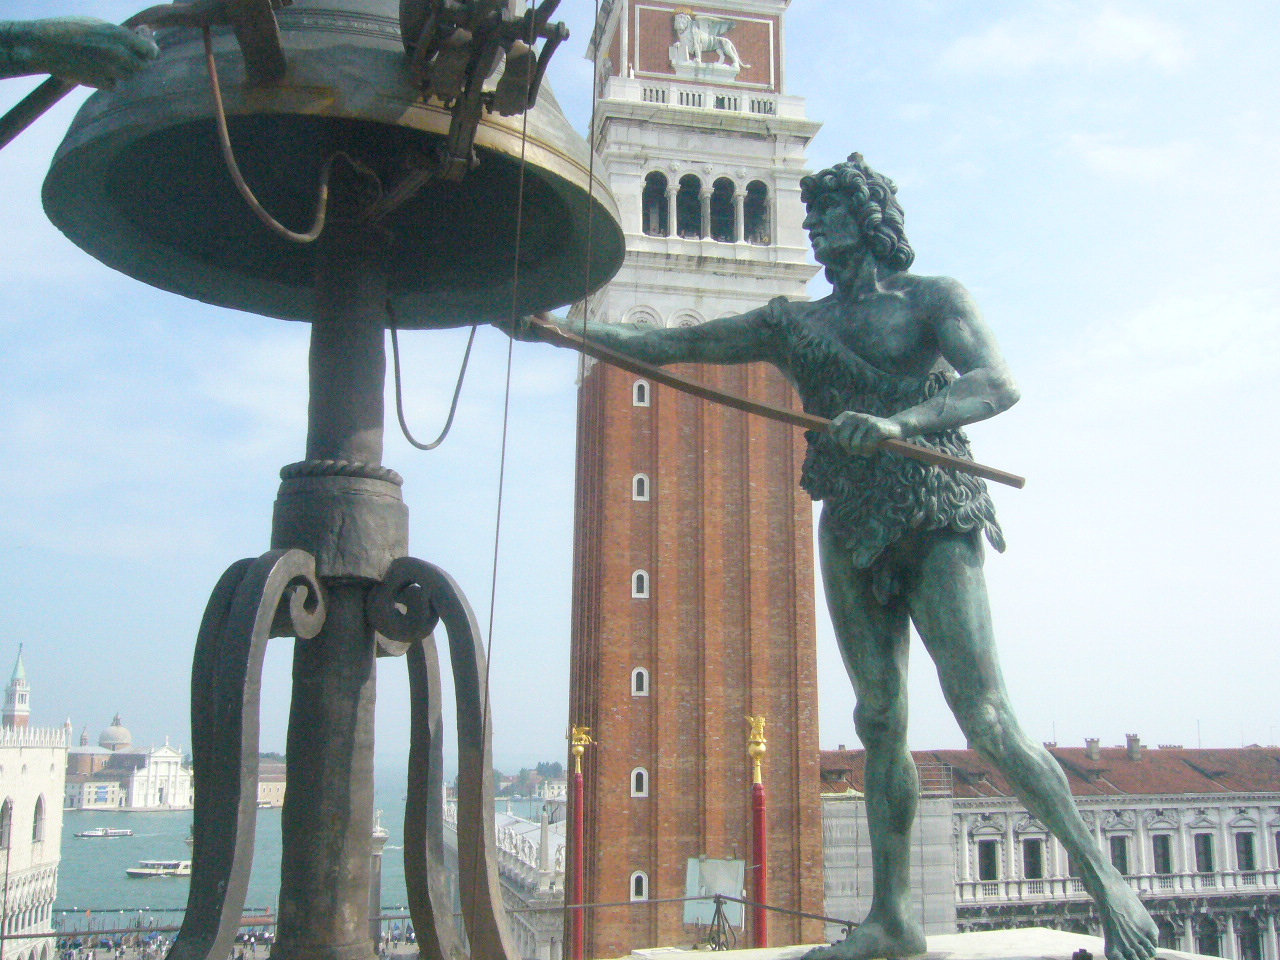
[819,746,1280,797]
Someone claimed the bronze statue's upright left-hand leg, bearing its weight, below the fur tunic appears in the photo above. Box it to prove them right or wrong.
[808,514,925,960]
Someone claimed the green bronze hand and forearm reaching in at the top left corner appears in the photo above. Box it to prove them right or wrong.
[0,17,160,87]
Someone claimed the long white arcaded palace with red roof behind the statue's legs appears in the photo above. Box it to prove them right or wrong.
[822,736,1280,960]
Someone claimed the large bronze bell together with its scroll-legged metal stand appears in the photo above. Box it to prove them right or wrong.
[33,0,623,960]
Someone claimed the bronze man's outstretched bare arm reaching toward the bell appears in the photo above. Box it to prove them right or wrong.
[512,307,776,366]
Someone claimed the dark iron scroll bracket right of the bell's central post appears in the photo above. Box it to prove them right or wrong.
[365,557,518,960]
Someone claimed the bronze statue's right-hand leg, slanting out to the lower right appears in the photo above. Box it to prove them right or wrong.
[908,531,1158,960]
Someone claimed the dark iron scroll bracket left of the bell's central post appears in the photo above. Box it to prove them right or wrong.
[168,549,325,960]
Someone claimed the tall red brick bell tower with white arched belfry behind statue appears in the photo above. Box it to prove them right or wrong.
[570,0,823,957]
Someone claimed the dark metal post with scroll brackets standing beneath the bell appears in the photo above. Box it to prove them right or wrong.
[169,237,516,960]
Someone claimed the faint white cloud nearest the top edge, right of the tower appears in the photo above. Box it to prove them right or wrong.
[942,4,1190,73]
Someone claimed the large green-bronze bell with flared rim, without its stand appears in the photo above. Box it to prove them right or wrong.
[44,0,623,326]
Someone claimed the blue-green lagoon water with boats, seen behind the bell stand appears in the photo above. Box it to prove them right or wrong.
[54,771,541,929]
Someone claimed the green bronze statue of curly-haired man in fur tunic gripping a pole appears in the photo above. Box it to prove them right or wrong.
[516,154,1157,960]
